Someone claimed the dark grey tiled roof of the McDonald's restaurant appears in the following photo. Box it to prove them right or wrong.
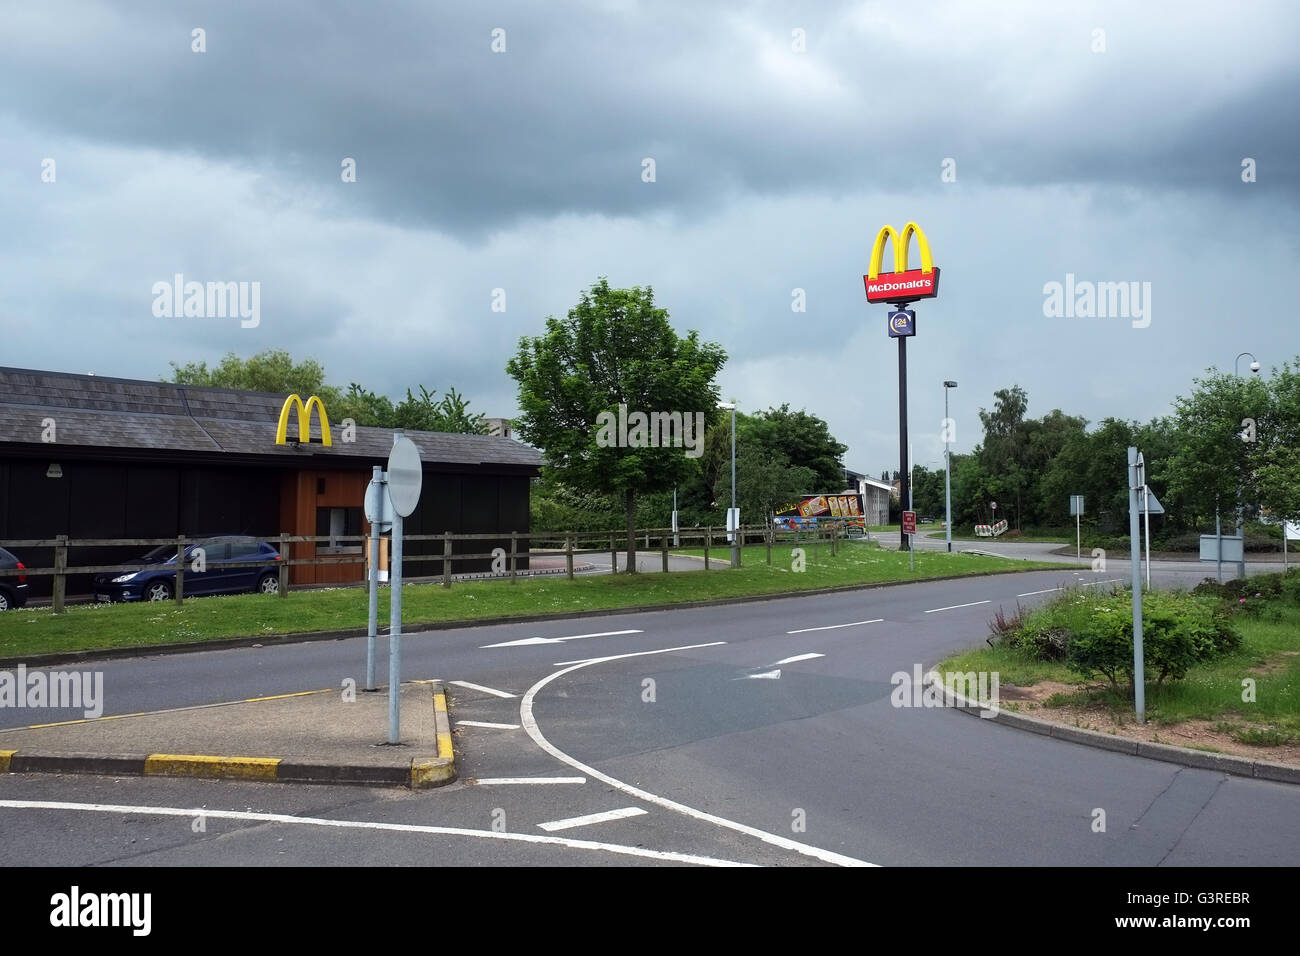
[0,368,541,467]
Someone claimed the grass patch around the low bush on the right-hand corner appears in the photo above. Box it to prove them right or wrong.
[935,602,1300,744]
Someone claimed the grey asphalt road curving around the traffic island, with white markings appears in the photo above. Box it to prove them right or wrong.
[0,566,1300,866]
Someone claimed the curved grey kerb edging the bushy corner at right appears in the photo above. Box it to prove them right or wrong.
[923,670,1300,783]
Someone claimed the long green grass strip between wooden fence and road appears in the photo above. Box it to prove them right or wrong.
[0,544,1057,658]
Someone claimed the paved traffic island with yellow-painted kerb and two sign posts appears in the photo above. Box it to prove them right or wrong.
[0,680,456,790]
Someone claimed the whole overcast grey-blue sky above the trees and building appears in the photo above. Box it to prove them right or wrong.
[0,0,1300,473]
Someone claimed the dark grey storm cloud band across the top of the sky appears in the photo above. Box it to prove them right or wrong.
[0,0,1300,238]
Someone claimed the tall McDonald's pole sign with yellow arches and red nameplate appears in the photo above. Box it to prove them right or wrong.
[862,222,939,550]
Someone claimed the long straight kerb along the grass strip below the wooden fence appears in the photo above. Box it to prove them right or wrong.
[0,567,1057,667]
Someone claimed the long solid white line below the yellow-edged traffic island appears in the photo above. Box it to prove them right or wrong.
[0,800,753,866]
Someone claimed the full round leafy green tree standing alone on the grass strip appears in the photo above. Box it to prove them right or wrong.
[506,277,727,572]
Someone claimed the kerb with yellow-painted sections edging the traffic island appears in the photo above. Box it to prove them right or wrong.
[0,682,456,790]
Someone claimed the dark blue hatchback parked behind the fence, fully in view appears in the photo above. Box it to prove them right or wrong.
[94,535,280,602]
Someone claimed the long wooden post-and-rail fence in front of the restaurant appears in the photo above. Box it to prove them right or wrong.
[0,525,844,614]
